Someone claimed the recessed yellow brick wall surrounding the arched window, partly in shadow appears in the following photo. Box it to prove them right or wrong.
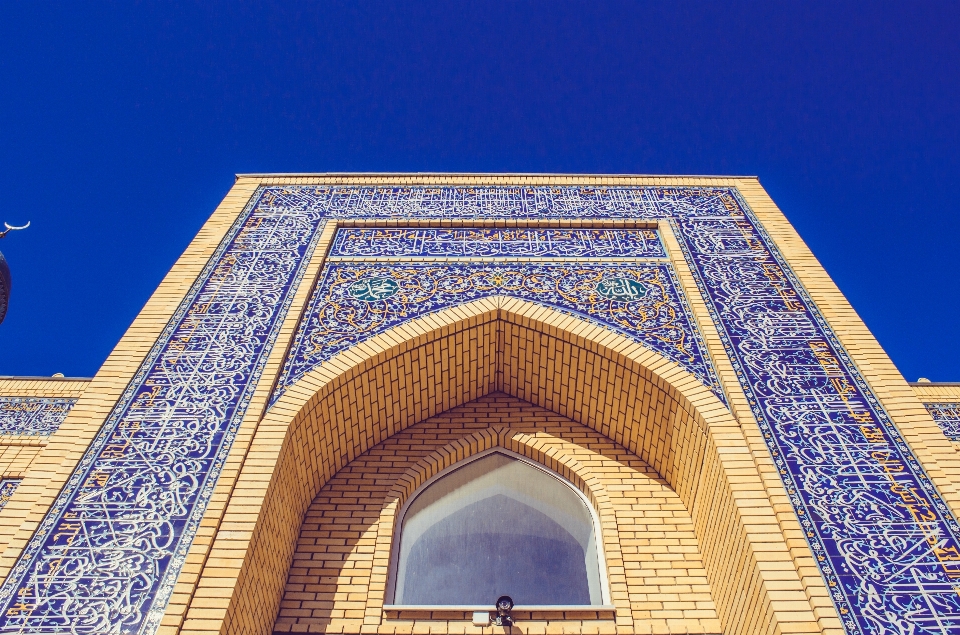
[275,393,720,633]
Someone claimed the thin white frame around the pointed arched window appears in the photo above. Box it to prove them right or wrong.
[383,446,615,612]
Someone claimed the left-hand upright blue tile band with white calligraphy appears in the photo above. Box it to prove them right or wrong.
[0,199,330,634]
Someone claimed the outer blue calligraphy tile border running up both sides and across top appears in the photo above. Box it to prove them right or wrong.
[0,186,960,635]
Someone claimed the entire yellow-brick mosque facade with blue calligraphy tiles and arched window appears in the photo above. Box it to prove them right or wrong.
[0,174,960,635]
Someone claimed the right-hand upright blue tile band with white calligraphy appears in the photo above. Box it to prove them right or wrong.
[673,203,960,635]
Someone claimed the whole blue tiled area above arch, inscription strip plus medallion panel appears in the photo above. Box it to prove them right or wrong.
[272,227,724,402]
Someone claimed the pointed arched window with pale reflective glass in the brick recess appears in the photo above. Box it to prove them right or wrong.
[391,449,606,607]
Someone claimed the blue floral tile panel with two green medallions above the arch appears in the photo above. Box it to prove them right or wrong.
[274,261,723,401]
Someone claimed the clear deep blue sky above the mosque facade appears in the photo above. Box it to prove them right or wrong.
[0,0,960,381]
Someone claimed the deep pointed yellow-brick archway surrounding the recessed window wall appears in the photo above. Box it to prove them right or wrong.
[184,298,820,634]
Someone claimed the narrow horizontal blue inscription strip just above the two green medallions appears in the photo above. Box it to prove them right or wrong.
[330,227,667,258]
